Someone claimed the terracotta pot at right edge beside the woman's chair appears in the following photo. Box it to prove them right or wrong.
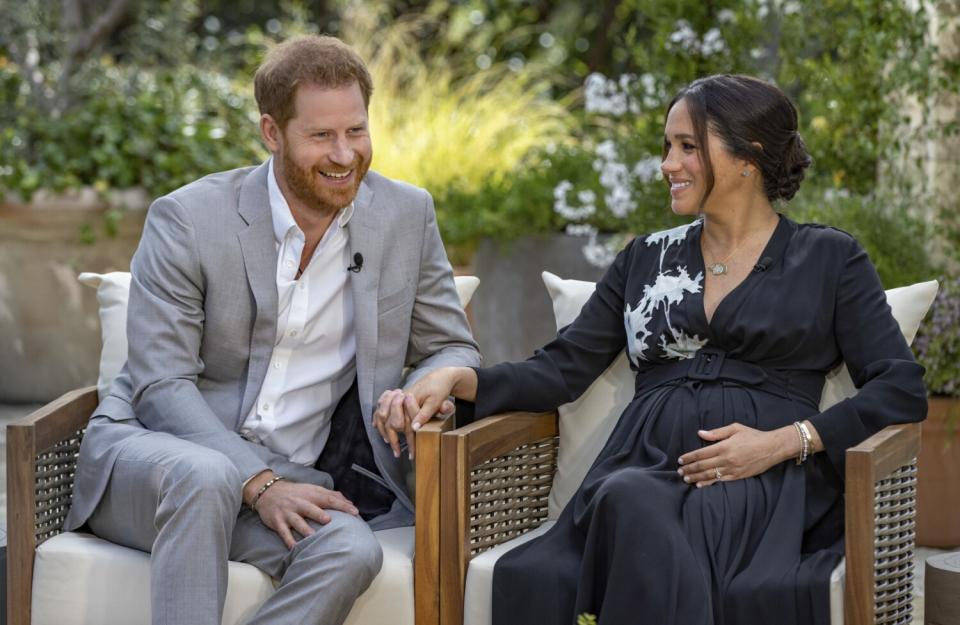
[917,397,960,547]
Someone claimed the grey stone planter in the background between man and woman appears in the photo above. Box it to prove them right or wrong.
[471,234,604,366]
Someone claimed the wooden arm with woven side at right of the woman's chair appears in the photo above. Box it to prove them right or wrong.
[843,423,920,625]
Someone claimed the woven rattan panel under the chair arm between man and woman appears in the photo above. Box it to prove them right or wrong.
[470,436,559,556]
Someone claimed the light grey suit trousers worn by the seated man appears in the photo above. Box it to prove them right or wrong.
[88,423,383,625]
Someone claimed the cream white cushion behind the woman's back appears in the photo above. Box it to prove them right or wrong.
[542,271,938,519]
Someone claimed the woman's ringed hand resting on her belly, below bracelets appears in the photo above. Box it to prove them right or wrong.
[677,423,800,488]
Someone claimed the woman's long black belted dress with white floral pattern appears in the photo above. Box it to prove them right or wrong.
[475,216,926,625]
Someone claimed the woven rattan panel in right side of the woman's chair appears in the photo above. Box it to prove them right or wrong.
[874,460,917,625]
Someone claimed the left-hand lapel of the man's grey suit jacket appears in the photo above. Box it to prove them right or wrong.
[237,160,277,429]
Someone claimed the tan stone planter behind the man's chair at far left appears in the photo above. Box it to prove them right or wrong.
[0,204,146,403]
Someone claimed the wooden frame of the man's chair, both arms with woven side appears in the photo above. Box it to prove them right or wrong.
[7,386,453,625]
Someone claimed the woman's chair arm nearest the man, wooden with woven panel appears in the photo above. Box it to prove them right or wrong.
[438,412,558,625]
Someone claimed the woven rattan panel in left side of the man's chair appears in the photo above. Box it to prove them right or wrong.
[34,430,84,546]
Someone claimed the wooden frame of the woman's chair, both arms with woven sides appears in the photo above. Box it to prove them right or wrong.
[442,412,920,625]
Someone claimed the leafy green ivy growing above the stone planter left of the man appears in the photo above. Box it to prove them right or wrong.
[0,61,263,198]
